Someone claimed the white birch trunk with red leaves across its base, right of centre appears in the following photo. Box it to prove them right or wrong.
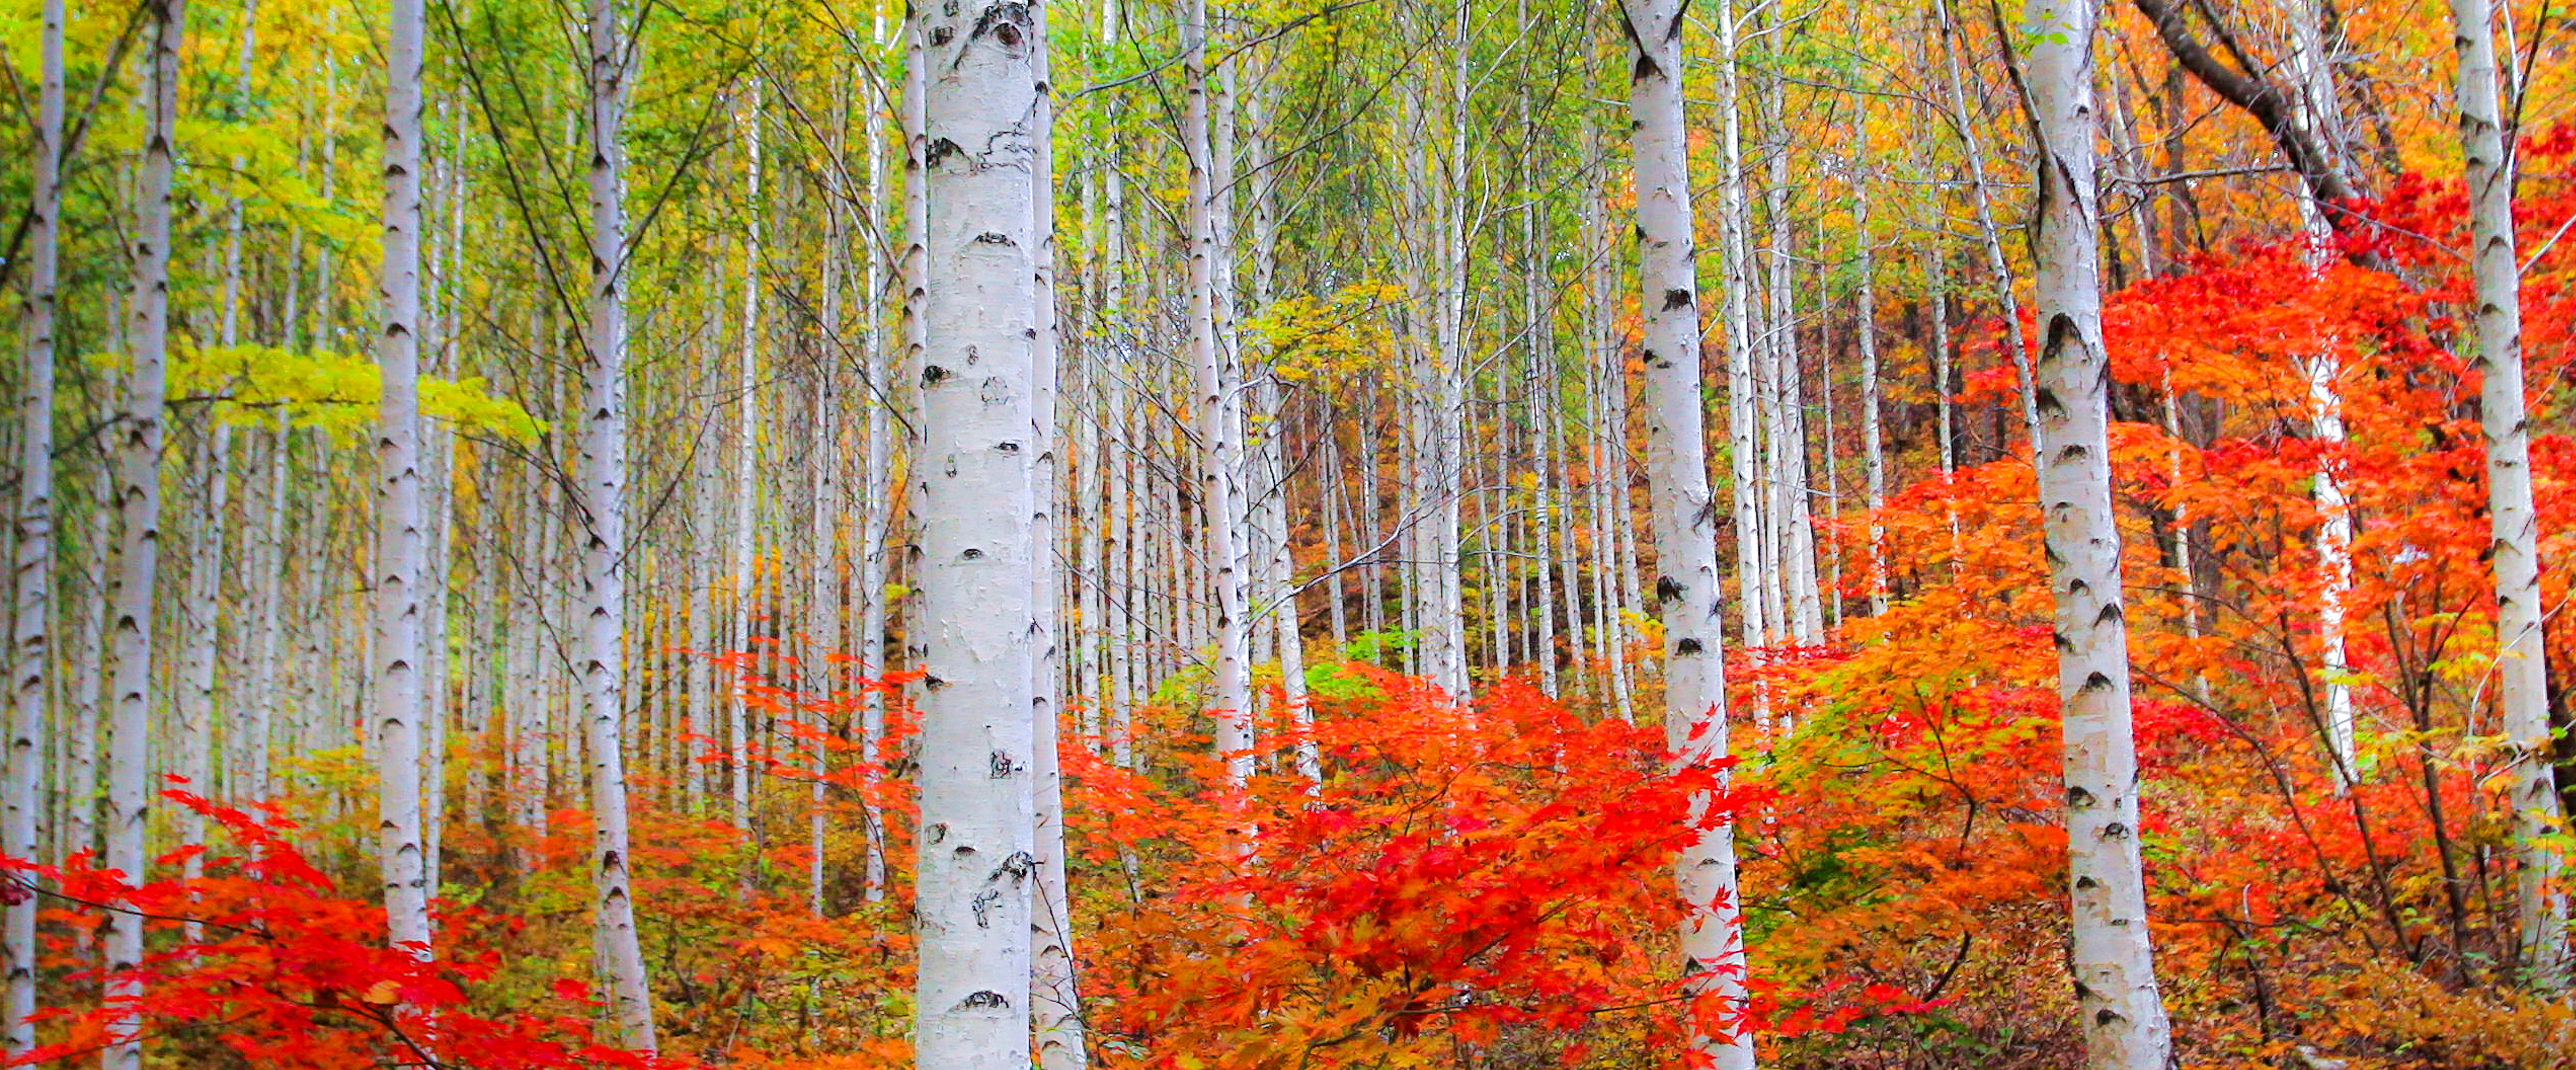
[1620,0,1754,1070]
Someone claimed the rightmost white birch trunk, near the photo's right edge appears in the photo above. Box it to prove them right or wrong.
[2450,0,2571,993]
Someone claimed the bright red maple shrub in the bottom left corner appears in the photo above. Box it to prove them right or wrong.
[0,779,688,1070]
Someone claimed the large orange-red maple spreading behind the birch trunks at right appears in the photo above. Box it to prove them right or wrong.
[1772,147,2576,1070]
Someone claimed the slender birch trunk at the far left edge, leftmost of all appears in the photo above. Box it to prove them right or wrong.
[0,0,64,1054]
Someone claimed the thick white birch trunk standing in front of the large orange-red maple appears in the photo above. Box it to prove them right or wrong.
[2022,0,2172,1070]
